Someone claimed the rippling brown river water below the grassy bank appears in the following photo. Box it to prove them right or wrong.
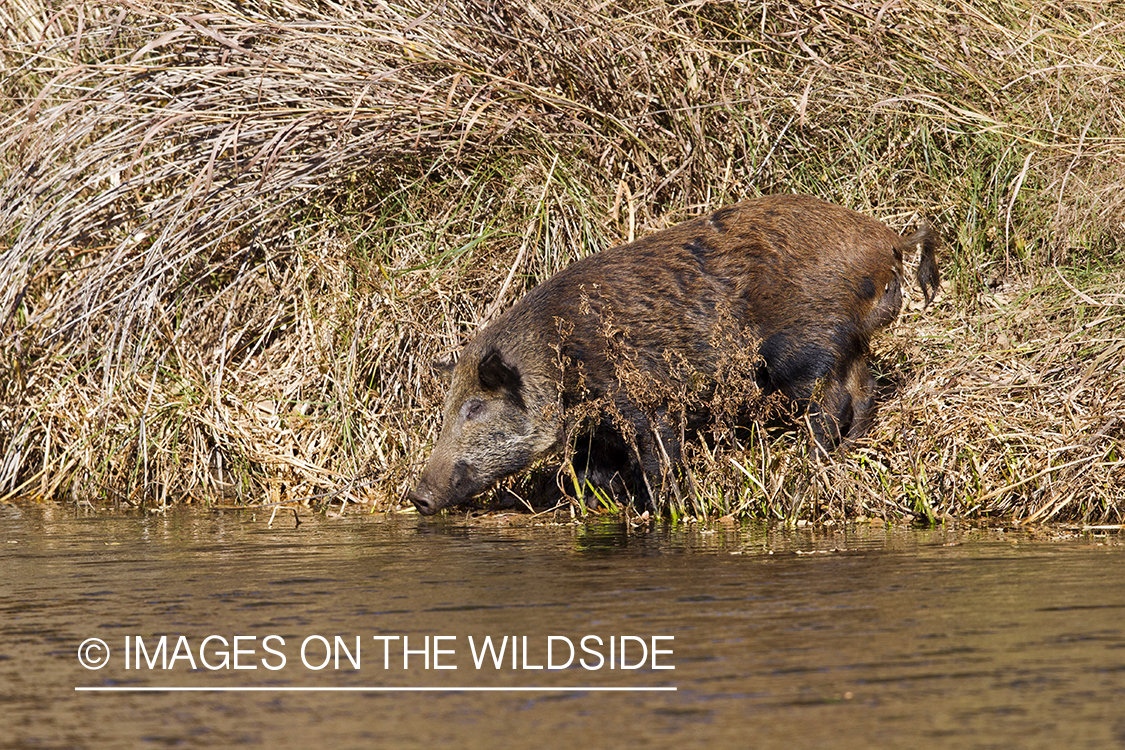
[0,505,1125,749]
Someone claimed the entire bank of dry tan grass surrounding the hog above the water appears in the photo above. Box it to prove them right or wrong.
[0,0,1125,522]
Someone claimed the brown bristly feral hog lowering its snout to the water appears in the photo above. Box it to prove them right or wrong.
[410,196,939,515]
